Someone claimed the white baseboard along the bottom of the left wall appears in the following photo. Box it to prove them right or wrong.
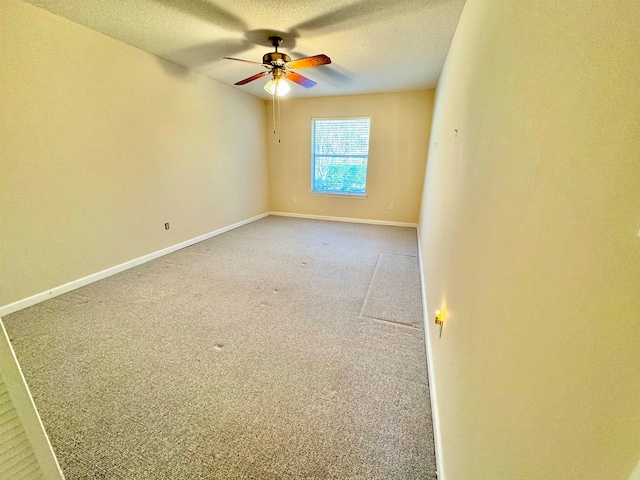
[0,212,269,317]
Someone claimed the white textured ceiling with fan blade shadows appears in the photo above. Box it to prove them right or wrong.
[22,0,464,98]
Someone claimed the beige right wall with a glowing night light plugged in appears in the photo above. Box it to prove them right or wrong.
[420,0,640,480]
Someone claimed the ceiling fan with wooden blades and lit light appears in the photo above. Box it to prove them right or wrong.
[223,37,331,97]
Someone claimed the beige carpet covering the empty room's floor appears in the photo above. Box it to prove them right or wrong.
[4,217,435,480]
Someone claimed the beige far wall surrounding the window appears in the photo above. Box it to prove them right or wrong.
[266,91,434,223]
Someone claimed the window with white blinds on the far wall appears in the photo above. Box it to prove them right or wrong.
[311,118,371,195]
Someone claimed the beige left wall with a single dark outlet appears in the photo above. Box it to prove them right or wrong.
[0,0,268,305]
